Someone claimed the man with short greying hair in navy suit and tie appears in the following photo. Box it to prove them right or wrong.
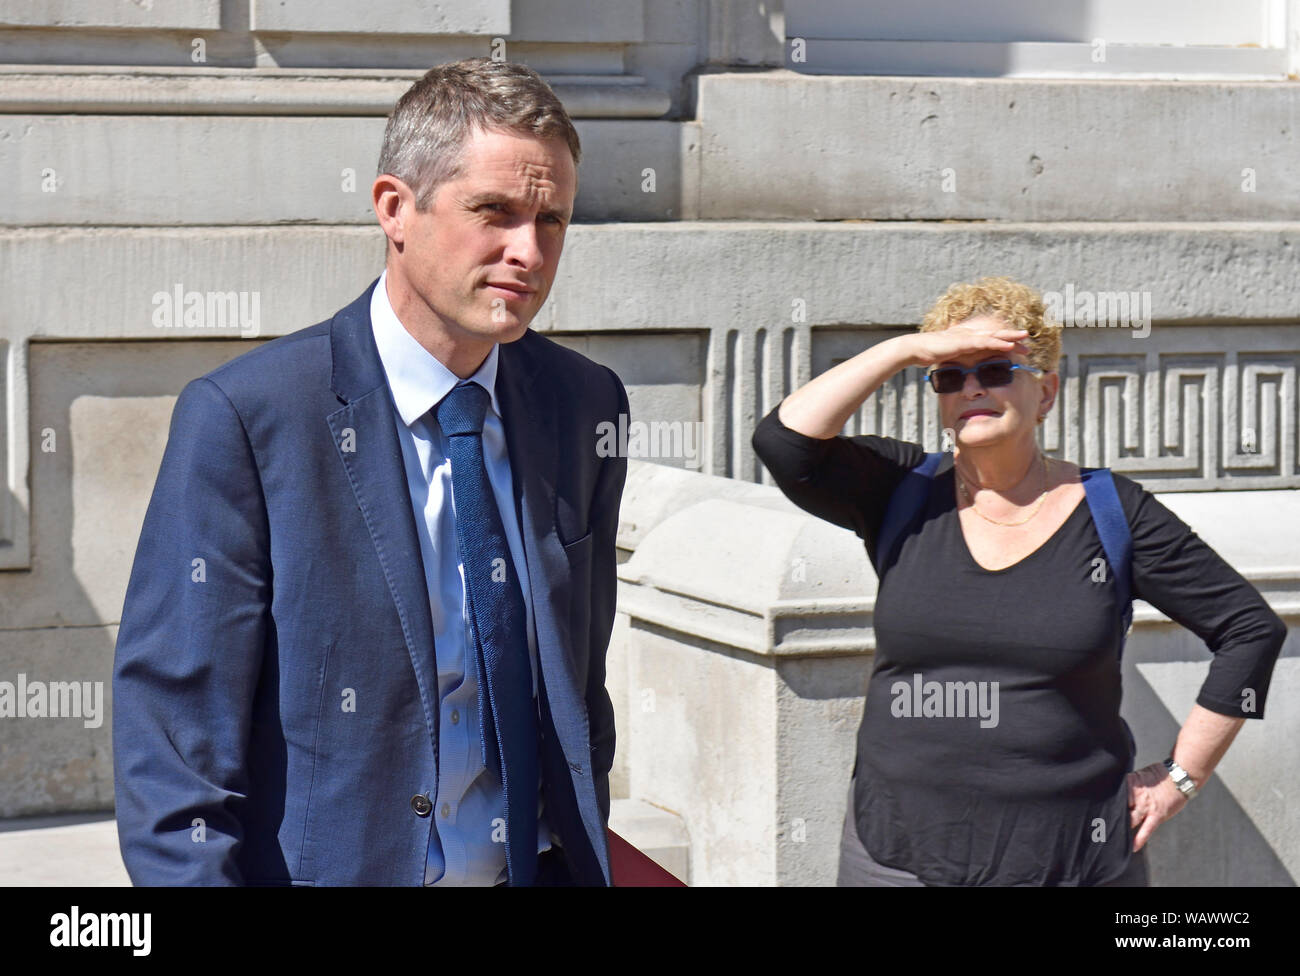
[113,58,628,885]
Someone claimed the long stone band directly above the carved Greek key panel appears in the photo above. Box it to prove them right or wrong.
[0,222,1300,326]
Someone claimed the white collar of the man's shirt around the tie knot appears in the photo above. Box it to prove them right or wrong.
[371,270,501,426]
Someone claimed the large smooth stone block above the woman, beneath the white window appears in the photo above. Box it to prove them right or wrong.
[697,70,1300,221]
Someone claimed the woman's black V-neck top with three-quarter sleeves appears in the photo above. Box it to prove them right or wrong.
[753,400,1287,885]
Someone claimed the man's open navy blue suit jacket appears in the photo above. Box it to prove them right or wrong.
[113,283,628,885]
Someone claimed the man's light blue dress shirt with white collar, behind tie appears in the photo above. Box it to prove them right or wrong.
[371,272,553,886]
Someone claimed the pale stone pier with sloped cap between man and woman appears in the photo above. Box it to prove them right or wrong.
[611,464,874,885]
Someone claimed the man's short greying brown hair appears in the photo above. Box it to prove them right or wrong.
[378,57,582,211]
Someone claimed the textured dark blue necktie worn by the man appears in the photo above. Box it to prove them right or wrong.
[434,382,538,885]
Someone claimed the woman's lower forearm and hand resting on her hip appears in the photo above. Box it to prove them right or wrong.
[1128,704,1245,853]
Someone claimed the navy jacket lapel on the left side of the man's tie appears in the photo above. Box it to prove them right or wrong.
[325,283,438,763]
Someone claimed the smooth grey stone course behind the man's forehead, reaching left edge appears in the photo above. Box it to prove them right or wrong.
[0,113,699,226]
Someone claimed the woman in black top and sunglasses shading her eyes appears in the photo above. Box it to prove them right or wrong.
[753,278,1286,885]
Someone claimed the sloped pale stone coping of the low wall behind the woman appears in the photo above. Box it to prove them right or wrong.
[618,460,1300,658]
